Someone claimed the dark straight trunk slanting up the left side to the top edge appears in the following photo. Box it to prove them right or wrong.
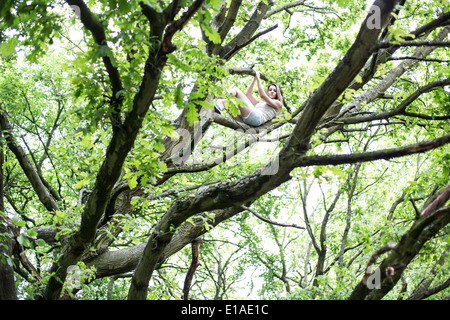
[45,2,207,299]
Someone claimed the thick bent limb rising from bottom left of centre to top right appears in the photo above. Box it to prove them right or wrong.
[128,1,395,299]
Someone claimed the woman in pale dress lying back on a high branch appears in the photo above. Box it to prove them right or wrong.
[215,71,283,127]
